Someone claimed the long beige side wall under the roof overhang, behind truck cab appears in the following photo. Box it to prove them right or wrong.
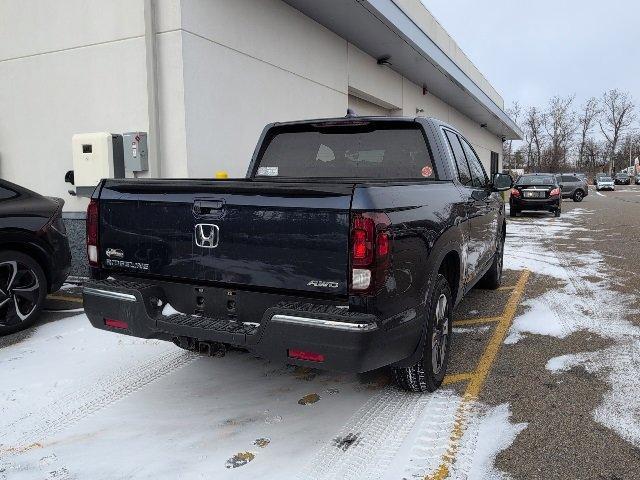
[182,0,502,177]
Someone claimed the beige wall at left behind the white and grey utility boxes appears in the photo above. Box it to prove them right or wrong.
[0,0,187,212]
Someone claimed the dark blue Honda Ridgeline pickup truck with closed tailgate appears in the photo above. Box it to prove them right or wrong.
[84,116,511,391]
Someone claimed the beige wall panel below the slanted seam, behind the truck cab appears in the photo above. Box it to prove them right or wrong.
[184,33,347,177]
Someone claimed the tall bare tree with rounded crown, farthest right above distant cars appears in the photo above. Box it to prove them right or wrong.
[598,89,635,173]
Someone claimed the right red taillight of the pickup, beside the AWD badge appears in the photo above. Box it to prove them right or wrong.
[350,212,391,293]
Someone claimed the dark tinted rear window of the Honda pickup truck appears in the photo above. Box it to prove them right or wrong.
[255,123,436,179]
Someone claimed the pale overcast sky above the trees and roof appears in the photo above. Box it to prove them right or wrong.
[423,0,640,115]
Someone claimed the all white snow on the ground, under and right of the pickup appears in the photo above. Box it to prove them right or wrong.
[7,209,640,480]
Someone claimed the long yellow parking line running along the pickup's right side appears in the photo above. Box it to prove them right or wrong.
[424,270,530,480]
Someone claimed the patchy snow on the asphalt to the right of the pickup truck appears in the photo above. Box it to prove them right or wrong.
[505,208,640,447]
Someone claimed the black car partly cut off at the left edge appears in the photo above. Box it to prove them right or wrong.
[0,179,71,335]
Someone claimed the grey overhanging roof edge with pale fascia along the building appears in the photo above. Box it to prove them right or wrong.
[284,0,523,140]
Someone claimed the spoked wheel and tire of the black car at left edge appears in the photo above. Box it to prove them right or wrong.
[0,251,47,336]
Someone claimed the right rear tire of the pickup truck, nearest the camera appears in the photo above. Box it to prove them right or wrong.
[393,274,452,392]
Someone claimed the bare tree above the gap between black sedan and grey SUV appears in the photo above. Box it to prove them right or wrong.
[544,95,576,172]
